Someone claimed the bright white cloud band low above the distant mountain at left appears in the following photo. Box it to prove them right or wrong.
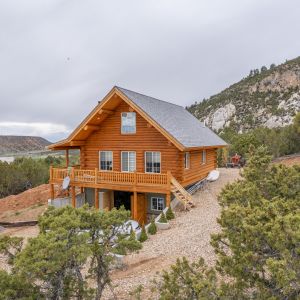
[0,122,70,139]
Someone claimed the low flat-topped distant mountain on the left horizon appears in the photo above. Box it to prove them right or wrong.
[0,135,51,155]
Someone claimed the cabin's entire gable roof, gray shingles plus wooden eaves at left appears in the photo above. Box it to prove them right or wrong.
[48,87,227,150]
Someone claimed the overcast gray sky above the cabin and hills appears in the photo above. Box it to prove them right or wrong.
[0,0,300,141]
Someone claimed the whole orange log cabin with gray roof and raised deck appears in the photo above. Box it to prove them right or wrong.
[48,87,226,223]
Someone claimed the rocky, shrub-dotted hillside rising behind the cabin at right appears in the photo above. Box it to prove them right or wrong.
[187,57,300,132]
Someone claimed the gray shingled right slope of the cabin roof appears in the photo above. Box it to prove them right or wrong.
[116,87,227,148]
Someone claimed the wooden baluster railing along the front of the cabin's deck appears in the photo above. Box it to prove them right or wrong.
[50,167,168,186]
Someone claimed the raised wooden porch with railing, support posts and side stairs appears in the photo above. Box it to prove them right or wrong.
[49,166,191,221]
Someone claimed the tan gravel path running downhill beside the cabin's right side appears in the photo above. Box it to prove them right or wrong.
[105,169,239,299]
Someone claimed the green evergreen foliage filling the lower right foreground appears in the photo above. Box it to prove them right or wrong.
[156,147,300,299]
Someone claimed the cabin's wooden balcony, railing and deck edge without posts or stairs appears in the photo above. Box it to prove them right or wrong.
[50,167,171,192]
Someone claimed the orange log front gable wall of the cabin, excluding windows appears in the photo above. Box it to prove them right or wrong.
[80,102,182,180]
